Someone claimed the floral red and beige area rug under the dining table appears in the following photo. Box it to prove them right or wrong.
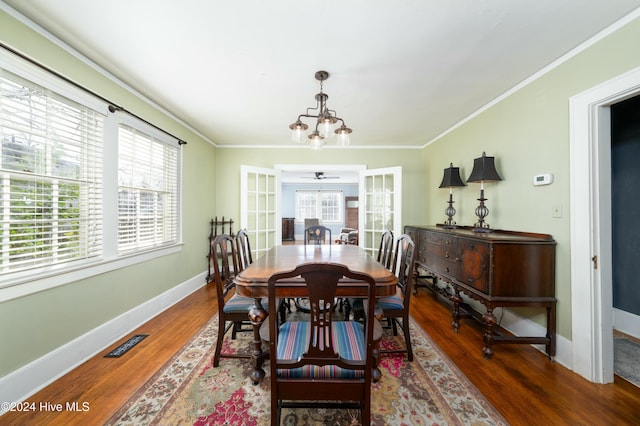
[106,310,507,426]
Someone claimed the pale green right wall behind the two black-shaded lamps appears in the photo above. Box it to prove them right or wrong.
[425,14,640,339]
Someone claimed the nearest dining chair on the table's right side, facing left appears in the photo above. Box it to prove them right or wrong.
[372,234,416,361]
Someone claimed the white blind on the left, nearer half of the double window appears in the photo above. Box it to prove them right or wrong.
[0,69,104,274]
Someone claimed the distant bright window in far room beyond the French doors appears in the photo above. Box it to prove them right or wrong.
[296,190,343,223]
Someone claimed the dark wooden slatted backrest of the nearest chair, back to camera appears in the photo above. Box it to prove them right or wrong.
[268,262,376,388]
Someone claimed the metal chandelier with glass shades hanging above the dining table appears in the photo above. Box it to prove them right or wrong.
[289,71,351,149]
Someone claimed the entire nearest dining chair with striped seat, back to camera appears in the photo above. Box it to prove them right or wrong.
[261,263,382,425]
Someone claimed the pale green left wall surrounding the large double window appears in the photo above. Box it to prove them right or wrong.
[0,11,216,377]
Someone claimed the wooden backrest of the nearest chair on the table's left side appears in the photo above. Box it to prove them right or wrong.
[210,234,238,312]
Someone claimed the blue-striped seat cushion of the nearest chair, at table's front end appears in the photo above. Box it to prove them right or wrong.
[278,321,366,379]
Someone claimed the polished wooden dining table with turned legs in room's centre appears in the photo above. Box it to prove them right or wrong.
[234,244,398,383]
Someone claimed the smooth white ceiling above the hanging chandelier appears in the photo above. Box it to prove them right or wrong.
[0,0,640,150]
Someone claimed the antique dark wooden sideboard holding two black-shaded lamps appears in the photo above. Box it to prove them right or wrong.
[405,226,556,358]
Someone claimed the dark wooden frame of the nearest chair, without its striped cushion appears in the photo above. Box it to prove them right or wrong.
[268,263,376,425]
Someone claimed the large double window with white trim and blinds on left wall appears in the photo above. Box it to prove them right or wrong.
[0,51,181,292]
